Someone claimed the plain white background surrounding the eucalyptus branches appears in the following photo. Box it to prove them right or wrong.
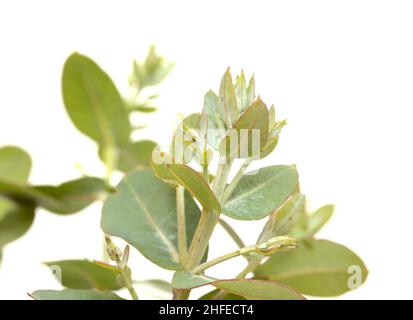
[0,0,413,299]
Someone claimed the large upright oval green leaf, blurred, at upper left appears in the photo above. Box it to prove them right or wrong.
[62,53,131,149]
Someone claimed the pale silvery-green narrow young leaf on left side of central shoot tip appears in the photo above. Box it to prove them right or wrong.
[202,90,227,150]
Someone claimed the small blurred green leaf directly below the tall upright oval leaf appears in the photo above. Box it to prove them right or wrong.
[118,140,156,172]
